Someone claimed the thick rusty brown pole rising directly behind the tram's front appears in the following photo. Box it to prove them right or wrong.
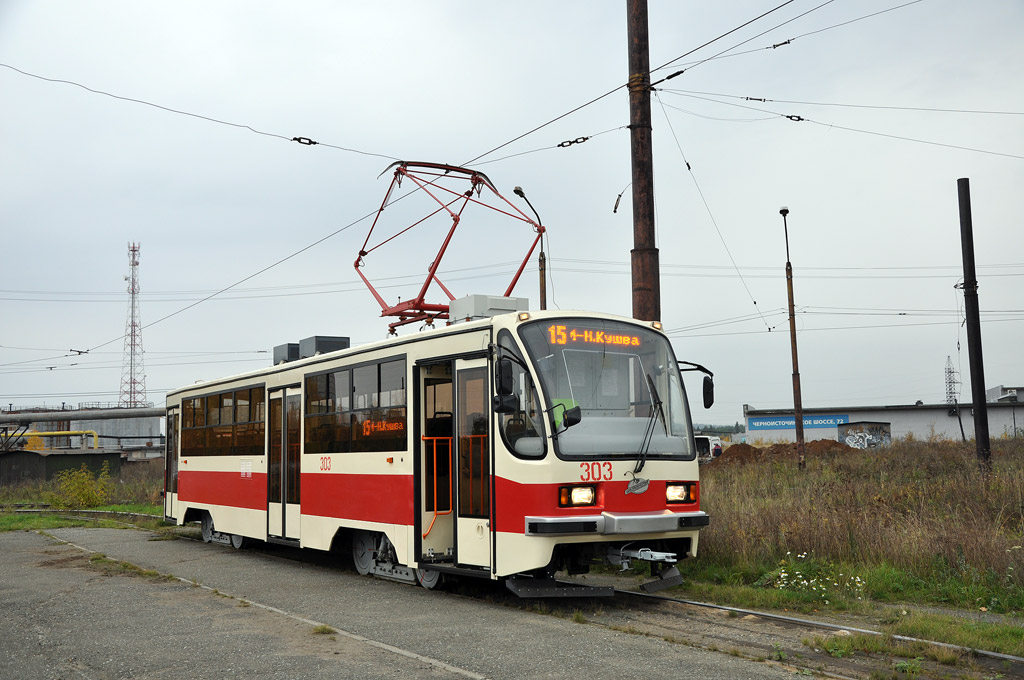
[626,0,662,322]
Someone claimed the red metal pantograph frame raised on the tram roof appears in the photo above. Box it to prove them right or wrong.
[353,161,544,334]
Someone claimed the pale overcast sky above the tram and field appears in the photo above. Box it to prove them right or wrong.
[0,0,1024,423]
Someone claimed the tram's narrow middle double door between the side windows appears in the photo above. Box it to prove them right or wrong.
[266,388,302,539]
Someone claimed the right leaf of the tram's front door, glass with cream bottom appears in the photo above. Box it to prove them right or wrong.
[455,358,492,566]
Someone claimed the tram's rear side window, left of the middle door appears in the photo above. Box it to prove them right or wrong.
[181,387,266,456]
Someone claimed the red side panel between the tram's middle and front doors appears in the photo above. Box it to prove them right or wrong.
[300,472,415,525]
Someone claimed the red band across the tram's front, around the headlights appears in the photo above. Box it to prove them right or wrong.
[495,477,699,534]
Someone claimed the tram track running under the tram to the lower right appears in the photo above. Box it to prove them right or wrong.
[24,508,1024,678]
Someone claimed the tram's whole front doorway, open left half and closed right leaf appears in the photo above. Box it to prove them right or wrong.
[419,358,493,567]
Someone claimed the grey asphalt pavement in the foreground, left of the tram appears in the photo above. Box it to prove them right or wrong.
[0,528,793,680]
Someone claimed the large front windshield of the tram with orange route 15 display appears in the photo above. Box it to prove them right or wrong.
[520,318,694,459]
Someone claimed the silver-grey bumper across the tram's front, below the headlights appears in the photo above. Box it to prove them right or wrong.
[526,510,711,536]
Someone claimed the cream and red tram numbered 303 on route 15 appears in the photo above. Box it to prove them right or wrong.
[165,311,711,596]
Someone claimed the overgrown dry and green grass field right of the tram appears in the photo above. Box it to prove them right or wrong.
[676,439,1024,655]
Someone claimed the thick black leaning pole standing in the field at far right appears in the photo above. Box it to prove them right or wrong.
[956,177,991,470]
